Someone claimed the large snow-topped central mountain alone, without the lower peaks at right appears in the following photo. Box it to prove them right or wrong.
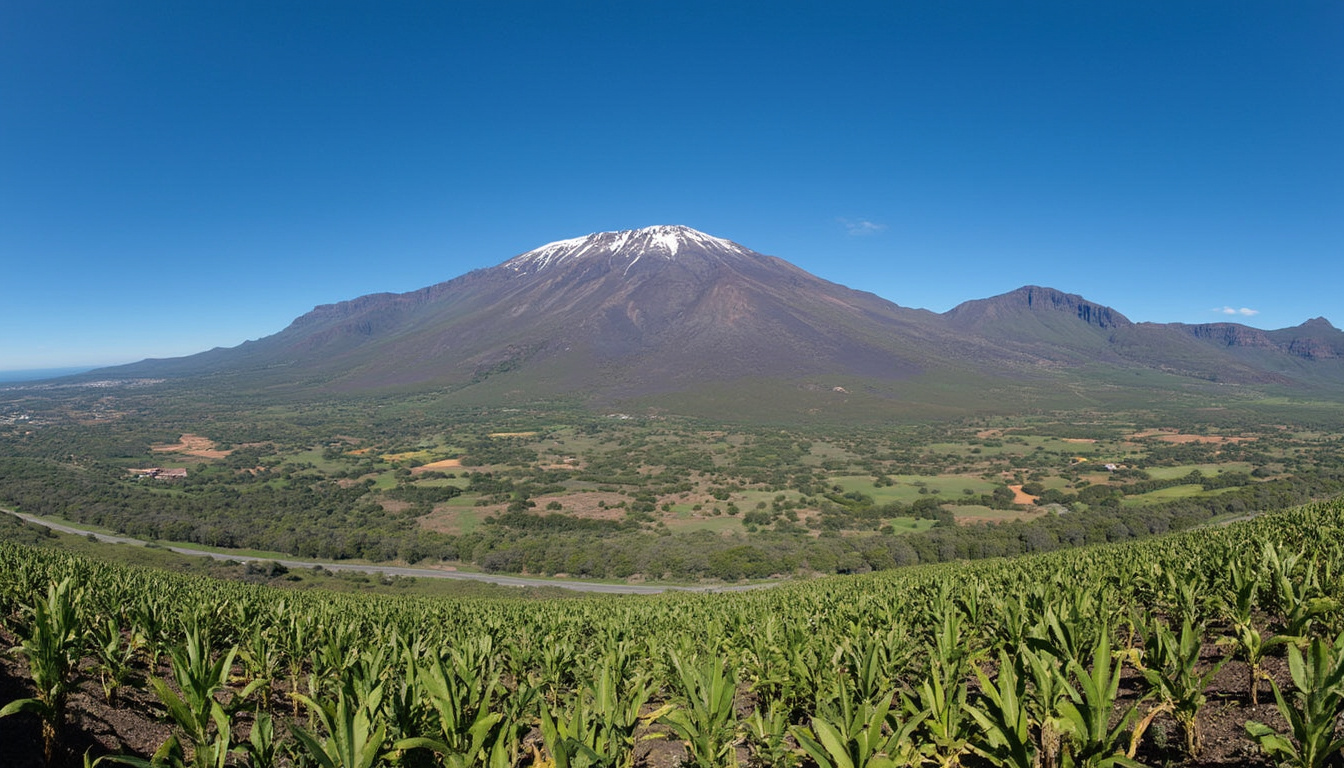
[99,227,973,397]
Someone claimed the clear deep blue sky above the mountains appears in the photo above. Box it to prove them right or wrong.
[0,0,1344,370]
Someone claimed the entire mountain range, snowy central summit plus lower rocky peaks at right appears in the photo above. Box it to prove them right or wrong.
[89,226,1344,416]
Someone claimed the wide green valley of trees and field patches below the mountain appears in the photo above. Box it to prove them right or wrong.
[0,387,1344,581]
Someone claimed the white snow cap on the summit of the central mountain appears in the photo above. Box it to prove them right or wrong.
[504,225,749,273]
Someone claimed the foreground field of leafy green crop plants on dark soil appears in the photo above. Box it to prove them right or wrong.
[0,502,1344,768]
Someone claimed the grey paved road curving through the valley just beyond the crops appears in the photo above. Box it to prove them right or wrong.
[0,508,773,594]
